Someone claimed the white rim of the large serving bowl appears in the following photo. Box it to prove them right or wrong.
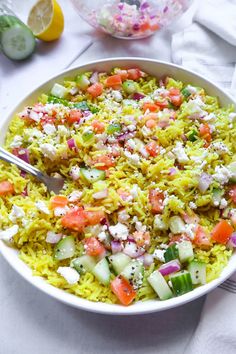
[0,57,236,315]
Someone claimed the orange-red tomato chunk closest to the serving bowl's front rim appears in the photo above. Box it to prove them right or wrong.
[111,276,136,306]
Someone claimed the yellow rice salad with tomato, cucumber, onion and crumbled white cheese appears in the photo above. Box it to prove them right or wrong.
[0,68,236,305]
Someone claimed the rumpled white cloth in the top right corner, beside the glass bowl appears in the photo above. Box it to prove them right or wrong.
[172,0,236,95]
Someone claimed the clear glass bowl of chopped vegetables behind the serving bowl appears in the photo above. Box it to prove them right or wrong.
[71,0,193,39]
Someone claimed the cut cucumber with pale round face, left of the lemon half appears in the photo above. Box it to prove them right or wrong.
[0,15,36,60]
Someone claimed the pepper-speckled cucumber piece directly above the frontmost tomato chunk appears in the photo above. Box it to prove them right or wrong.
[121,259,144,287]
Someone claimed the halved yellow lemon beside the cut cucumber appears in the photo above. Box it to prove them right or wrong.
[27,0,64,42]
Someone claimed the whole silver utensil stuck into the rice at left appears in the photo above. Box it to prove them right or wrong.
[0,147,65,194]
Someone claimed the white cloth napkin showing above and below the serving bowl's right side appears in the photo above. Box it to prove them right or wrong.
[172,0,236,354]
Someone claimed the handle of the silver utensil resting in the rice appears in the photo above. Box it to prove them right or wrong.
[0,147,45,182]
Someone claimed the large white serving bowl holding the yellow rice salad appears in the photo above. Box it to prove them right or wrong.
[0,58,236,315]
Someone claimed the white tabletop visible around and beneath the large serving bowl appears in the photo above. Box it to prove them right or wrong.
[0,0,204,354]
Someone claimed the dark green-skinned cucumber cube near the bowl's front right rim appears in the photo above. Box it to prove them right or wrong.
[170,270,193,296]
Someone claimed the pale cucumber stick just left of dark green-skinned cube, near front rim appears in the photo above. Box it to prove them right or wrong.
[148,270,173,300]
